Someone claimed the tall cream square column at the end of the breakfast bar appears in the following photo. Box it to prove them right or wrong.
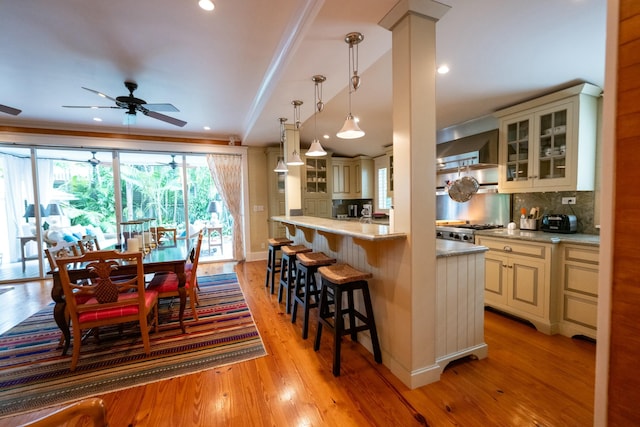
[380,0,449,388]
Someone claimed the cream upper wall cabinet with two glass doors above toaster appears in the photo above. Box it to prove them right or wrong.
[495,83,601,193]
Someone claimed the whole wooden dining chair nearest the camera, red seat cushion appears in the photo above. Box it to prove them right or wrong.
[58,251,158,371]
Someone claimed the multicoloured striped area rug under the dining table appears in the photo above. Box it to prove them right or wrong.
[0,273,266,417]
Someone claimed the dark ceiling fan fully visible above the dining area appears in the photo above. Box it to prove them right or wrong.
[63,82,187,127]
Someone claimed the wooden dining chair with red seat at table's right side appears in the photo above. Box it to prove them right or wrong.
[147,231,204,321]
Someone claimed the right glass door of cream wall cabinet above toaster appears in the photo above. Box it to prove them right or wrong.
[538,109,568,180]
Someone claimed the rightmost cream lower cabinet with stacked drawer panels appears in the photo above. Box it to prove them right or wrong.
[559,244,599,339]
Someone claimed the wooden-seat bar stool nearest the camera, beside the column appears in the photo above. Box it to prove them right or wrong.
[313,264,382,377]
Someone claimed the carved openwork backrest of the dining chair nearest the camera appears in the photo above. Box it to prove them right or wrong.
[58,250,145,316]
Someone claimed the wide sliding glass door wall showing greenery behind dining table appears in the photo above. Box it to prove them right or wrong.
[0,146,233,283]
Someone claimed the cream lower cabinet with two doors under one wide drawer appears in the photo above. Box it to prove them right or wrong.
[476,236,558,334]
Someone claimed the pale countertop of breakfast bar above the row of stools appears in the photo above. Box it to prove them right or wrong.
[272,216,407,241]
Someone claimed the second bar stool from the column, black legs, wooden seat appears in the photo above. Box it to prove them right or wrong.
[291,252,336,340]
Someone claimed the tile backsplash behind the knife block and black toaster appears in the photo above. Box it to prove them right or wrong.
[512,191,599,234]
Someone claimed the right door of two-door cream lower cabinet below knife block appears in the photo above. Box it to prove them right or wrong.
[507,257,547,317]
